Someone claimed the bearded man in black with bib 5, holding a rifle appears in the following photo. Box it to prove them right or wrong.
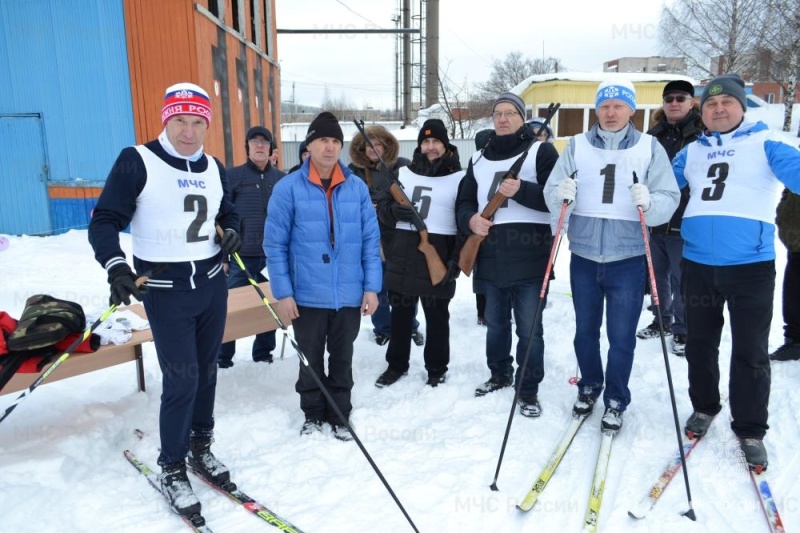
[375,119,464,387]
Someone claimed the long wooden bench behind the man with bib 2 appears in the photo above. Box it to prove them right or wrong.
[0,281,278,394]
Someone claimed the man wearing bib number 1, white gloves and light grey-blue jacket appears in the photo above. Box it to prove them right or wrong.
[545,80,680,431]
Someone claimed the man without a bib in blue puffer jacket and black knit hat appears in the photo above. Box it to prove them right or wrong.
[264,112,382,440]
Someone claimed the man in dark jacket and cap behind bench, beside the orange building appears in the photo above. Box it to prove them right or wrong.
[218,126,286,368]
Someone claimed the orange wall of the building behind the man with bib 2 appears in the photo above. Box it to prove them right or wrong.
[124,0,280,165]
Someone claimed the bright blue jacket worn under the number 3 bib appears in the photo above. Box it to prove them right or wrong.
[672,122,800,266]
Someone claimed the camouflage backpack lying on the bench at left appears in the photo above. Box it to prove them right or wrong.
[7,294,86,351]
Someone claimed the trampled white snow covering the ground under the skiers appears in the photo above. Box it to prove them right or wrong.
[0,231,800,533]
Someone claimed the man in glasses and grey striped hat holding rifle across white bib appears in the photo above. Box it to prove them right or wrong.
[456,93,558,417]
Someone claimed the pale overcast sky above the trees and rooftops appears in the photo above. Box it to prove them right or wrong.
[276,0,662,109]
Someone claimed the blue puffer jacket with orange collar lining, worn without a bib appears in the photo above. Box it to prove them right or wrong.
[264,158,383,310]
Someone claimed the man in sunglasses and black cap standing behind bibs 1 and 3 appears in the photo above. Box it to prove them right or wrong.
[636,80,703,356]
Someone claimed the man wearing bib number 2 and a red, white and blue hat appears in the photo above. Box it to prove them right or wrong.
[89,83,241,516]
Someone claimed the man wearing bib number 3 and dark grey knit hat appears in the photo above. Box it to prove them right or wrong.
[673,74,800,470]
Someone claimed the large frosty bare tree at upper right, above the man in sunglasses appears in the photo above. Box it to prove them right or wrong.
[659,0,768,78]
